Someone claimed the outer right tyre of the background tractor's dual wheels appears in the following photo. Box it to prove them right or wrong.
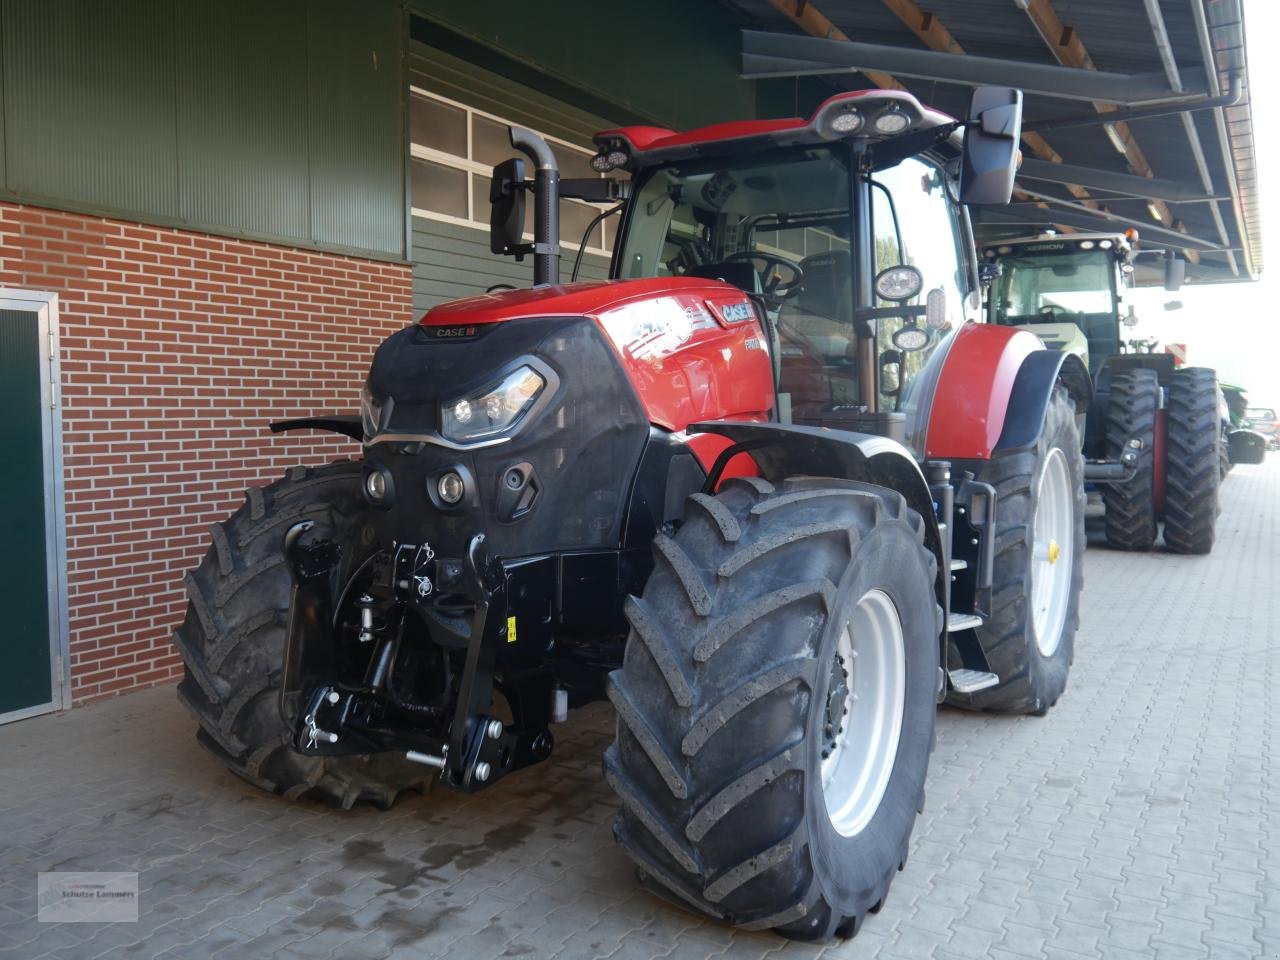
[1165,366,1221,553]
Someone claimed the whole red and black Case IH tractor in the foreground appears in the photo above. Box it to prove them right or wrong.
[175,88,1089,938]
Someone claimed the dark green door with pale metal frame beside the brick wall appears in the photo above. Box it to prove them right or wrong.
[0,289,70,722]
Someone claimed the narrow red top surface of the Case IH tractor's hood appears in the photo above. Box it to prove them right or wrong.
[419,276,745,326]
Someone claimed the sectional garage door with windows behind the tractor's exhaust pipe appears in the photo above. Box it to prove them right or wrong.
[408,44,616,314]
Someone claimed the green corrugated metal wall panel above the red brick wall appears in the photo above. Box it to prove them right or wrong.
[0,0,407,259]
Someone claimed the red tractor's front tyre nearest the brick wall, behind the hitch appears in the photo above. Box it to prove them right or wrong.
[173,462,429,808]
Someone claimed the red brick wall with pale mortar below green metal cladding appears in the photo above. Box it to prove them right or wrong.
[0,204,412,703]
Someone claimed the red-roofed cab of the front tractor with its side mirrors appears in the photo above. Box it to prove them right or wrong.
[490,88,1019,456]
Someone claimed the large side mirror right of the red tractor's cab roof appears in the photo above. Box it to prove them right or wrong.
[960,87,1023,205]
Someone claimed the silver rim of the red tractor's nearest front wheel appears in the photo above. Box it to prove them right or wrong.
[822,590,906,837]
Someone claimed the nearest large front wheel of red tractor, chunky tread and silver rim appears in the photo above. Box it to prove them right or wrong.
[604,477,942,940]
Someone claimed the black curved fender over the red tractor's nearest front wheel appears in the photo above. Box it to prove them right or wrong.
[689,420,950,605]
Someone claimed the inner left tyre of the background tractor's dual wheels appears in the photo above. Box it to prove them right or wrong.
[1102,370,1160,550]
